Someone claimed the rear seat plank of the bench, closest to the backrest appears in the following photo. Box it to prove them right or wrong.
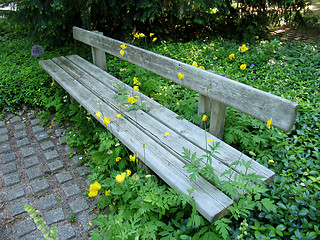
[58,55,274,182]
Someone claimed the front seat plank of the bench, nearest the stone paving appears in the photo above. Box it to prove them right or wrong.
[39,60,232,222]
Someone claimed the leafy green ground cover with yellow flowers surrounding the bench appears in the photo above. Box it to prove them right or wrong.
[0,16,320,239]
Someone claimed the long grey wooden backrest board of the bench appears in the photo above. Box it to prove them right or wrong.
[73,27,298,131]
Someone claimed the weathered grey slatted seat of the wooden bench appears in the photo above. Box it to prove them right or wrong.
[39,55,274,222]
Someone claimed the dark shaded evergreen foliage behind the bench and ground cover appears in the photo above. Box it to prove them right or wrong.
[2,0,308,44]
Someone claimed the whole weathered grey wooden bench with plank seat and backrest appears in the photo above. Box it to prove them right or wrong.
[39,27,298,222]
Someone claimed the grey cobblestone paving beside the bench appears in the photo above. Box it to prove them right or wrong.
[0,113,94,240]
